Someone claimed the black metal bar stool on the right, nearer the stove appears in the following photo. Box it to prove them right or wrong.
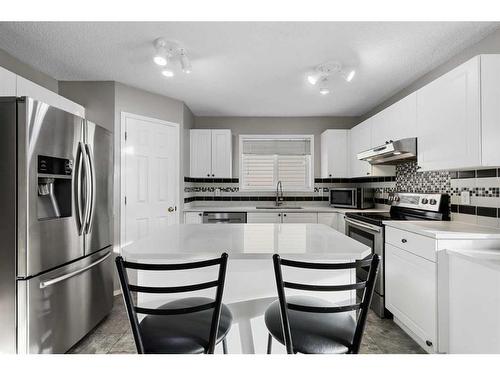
[265,254,379,354]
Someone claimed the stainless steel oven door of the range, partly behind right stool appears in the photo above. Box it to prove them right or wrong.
[345,217,385,316]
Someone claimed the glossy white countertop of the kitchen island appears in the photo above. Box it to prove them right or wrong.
[121,224,371,261]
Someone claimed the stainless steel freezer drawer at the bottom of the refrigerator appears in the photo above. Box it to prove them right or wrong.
[18,247,113,353]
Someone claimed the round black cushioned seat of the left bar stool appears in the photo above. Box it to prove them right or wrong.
[139,297,233,354]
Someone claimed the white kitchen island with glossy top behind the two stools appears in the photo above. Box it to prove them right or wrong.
[121,224,371,353]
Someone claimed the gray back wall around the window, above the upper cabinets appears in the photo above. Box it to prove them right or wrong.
[194,117,359,177]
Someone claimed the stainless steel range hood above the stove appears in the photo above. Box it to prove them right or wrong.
[358,138,417,165]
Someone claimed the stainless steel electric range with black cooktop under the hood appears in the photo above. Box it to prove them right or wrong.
[345,193,450,317]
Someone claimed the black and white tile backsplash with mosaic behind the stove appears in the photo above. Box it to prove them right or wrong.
[184,162,500,227]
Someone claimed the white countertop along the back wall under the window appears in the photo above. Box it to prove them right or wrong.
[184,204,389,213]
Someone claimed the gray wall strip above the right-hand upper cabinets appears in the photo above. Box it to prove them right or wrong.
[360,29,500,122]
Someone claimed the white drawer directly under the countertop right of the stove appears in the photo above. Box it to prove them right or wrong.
[385,227,437,262]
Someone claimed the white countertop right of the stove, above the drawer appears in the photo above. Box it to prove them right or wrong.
[384,220,500,240]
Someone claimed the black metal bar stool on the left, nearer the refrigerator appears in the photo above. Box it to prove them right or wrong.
[116,253,233,354]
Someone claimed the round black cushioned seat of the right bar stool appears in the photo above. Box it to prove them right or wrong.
[264,296,356,354]
